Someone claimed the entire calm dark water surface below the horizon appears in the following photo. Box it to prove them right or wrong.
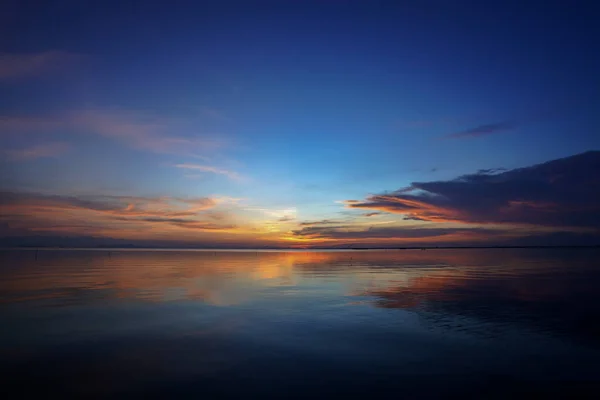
[0,250,600,399]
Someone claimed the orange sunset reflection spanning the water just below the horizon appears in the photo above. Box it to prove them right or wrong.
[0,250,592,307]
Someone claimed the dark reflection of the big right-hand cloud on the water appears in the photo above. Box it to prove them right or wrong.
[356,250,600,345]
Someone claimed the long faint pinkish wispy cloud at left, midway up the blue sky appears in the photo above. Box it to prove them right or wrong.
[0,109,226,158]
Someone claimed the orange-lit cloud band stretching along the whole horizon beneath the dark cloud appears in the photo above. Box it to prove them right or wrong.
[0,188,585,248]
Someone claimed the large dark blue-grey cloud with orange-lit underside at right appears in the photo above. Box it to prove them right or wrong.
[345,151,600,229]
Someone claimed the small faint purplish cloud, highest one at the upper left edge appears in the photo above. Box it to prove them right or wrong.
[0,50,81,80]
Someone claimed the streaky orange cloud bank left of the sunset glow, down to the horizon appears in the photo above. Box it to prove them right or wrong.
[0,192,300,247]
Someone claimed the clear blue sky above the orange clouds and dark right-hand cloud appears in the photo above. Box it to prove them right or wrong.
[0,0,600,244]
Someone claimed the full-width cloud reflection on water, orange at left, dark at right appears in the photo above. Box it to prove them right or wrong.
[0,250,600,340]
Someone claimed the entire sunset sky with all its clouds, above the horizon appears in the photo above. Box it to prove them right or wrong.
[0,0,600,248]
